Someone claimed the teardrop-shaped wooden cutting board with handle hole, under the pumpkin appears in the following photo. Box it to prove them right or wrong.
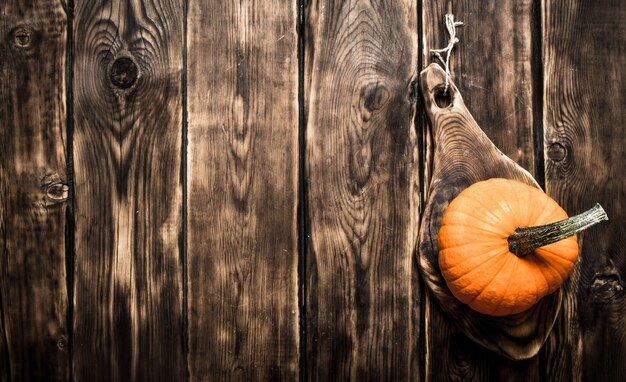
[418,64,561,360]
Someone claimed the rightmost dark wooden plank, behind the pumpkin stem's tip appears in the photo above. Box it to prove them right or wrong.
[542,0,626,381]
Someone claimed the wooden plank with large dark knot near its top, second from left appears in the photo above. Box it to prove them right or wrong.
[73,0,184,381]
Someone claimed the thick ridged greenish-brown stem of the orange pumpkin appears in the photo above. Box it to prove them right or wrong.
[508,203,609,257]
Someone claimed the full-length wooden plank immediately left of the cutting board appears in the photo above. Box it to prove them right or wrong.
[305,0,420,381]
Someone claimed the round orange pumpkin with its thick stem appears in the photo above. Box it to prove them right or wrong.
[438,178,608,316]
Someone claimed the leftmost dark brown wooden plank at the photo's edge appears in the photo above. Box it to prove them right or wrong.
[0,0,70,381]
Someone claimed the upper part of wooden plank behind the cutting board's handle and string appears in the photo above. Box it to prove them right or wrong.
[422,0,535,172]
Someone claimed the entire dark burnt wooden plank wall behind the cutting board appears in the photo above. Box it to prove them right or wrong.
[0,0,626,381]
